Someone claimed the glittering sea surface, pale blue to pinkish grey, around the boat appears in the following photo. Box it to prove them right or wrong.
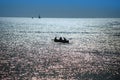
[0,17,120,80]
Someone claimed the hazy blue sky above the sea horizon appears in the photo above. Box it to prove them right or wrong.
[0,0,120,18]
